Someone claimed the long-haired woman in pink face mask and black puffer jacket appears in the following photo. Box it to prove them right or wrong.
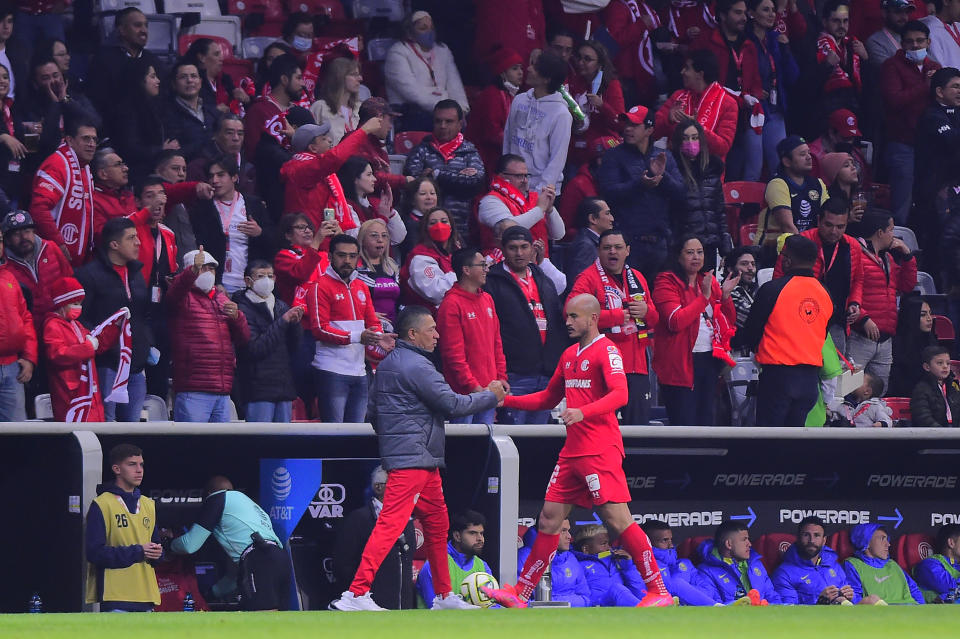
[672,120,730,271]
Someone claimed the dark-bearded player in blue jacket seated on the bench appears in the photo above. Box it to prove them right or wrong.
[773,516,856,606]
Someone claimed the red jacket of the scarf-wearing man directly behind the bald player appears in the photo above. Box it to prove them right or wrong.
[570,265,660,375]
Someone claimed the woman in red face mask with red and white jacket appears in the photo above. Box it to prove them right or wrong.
[400,209,463,312]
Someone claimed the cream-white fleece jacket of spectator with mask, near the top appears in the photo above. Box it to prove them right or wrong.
[383,40,470,113]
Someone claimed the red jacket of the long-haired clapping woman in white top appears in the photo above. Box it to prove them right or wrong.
[653,271,737,392]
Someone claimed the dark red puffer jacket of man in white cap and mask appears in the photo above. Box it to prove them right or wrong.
[165,268,250,395]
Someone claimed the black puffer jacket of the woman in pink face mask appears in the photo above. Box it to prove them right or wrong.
[673,156,727,248]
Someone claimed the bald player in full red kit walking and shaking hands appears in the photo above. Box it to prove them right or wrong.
[483,294,673,608]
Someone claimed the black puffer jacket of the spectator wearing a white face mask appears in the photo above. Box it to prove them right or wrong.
[231,289,303,404]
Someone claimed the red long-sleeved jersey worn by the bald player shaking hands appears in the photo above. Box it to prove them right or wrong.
[503,335,628,457]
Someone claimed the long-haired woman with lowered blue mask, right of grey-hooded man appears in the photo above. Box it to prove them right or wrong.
[567,40,627,164]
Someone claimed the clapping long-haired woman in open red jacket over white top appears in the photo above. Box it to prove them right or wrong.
[653,235,740,426]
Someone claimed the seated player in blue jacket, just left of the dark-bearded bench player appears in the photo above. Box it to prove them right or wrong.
[692,521,780,604]
